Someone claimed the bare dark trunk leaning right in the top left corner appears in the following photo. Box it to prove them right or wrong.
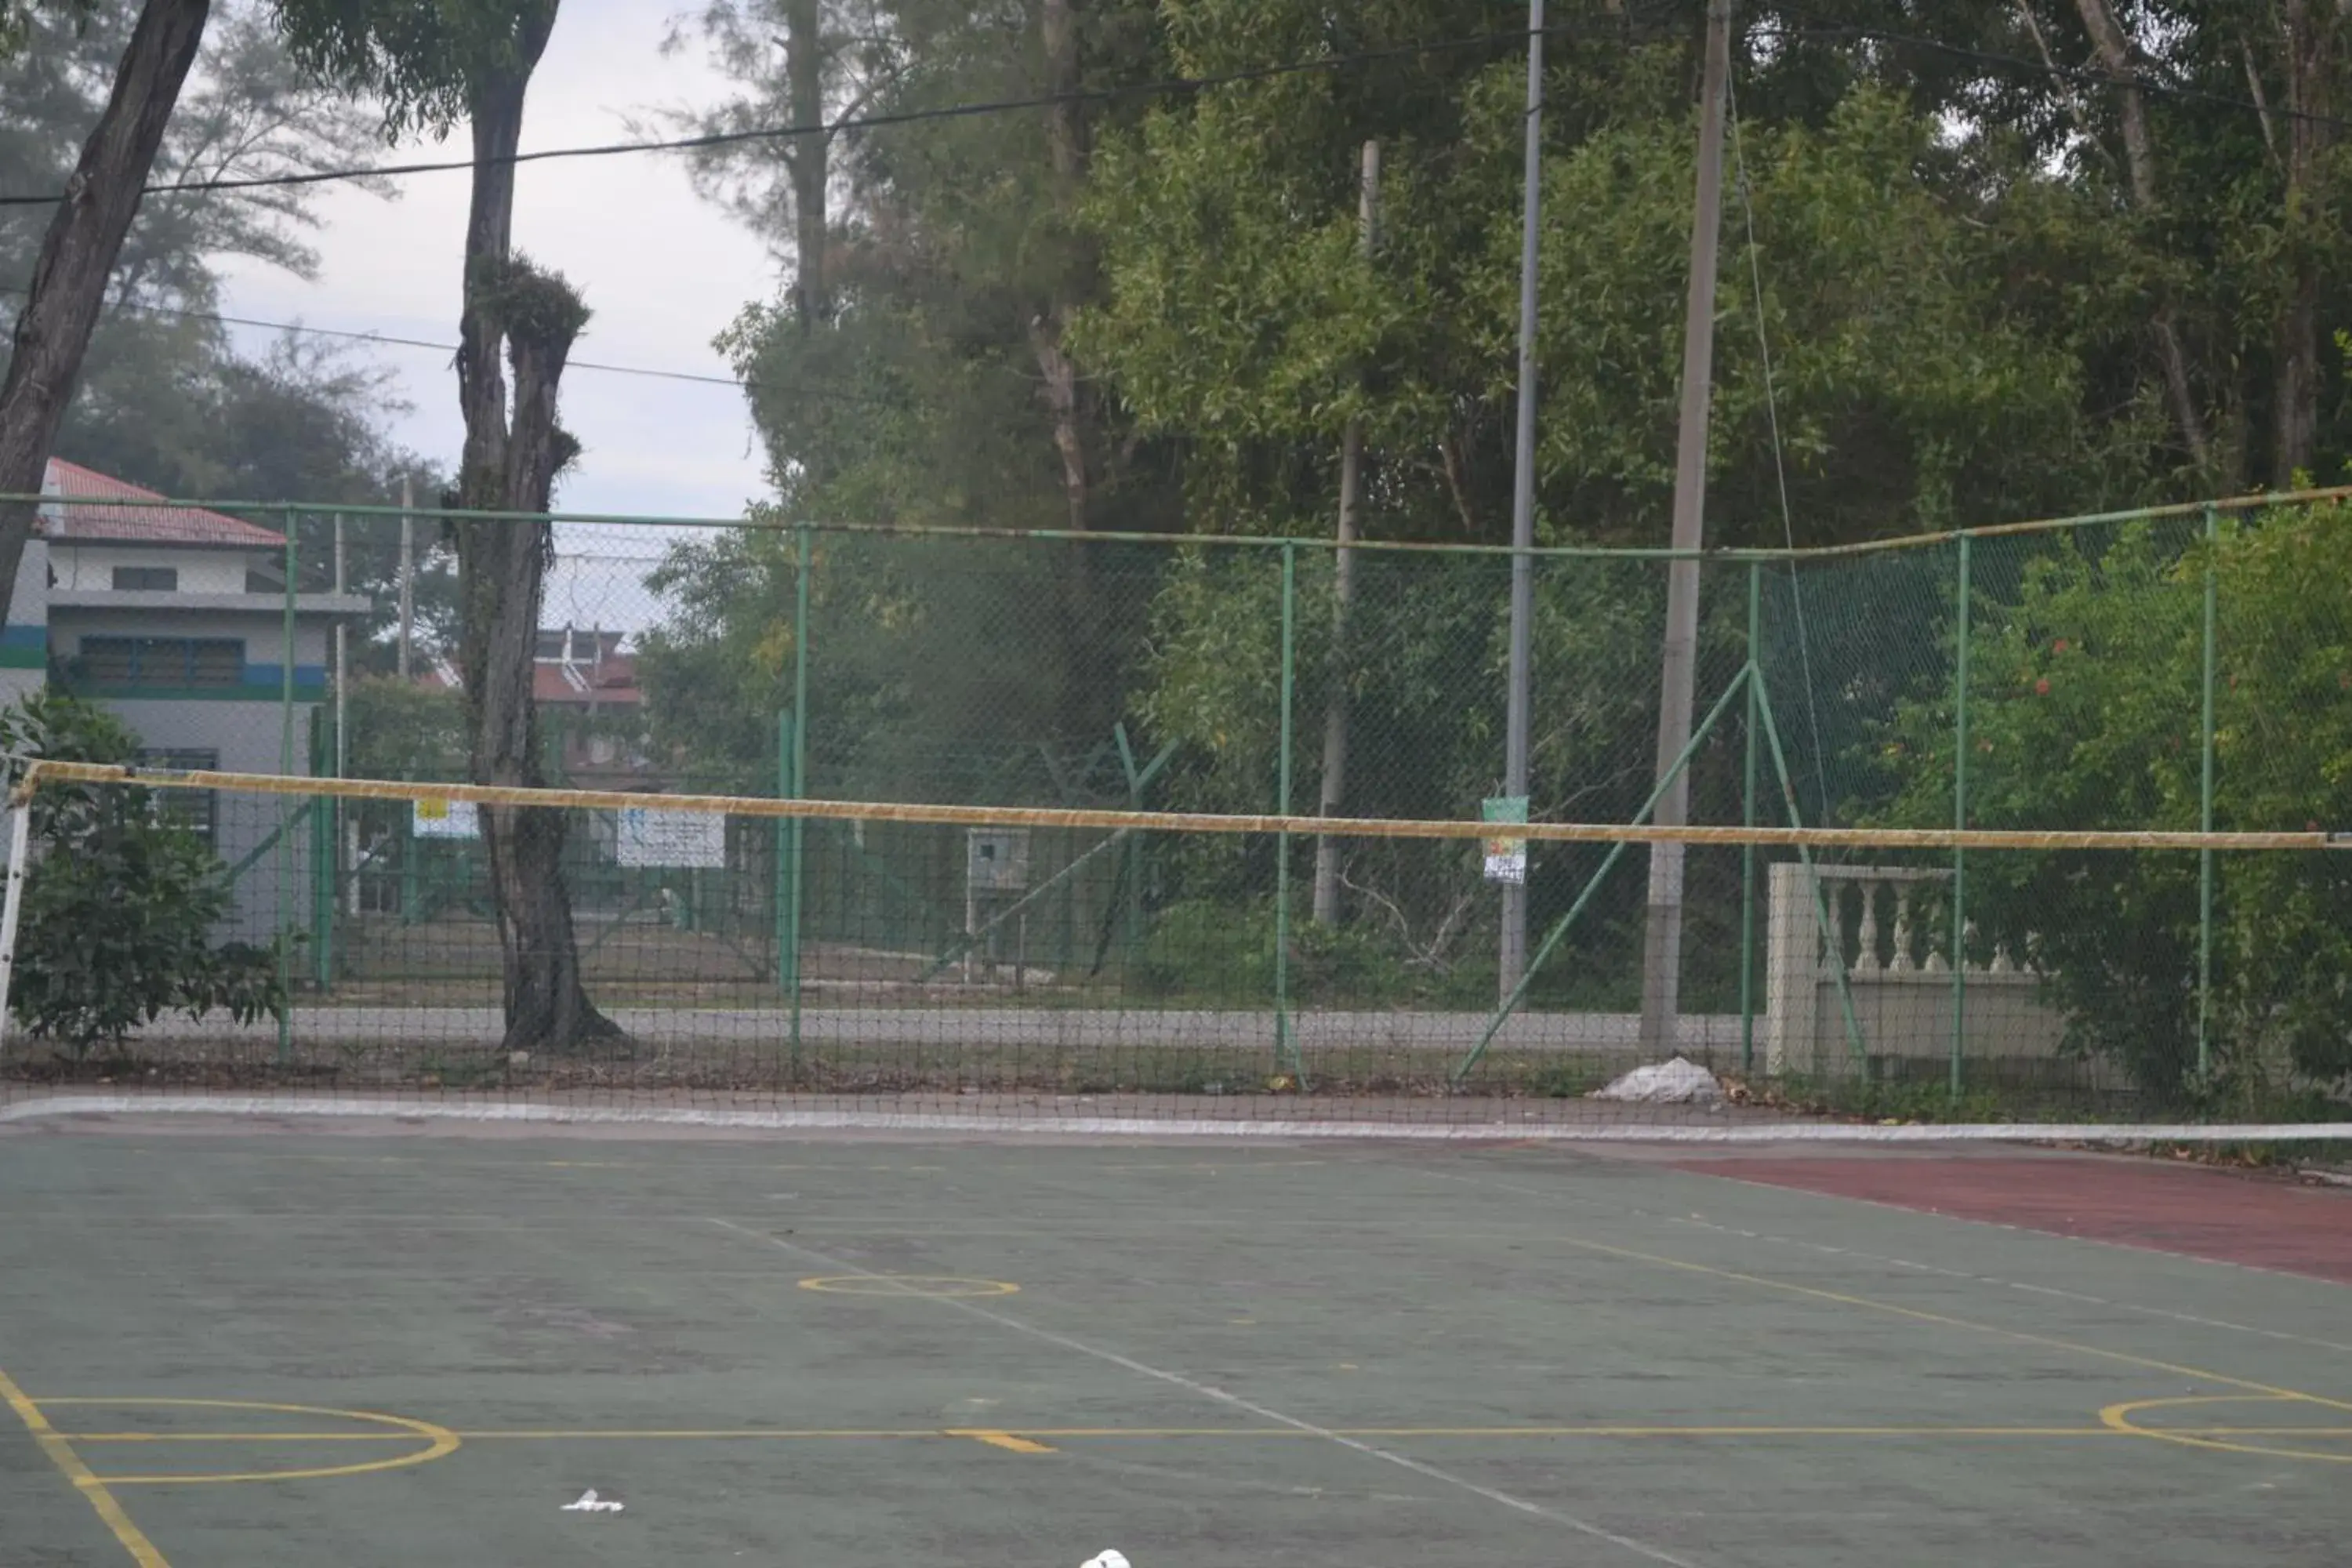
[0,0,212,604]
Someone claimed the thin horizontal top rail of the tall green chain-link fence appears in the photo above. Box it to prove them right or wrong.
[0,485,2352,564]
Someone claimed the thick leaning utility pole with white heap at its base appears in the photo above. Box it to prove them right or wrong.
[1642,0,1731,1058]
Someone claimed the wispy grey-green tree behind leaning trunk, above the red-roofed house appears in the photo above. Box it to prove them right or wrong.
[0,5,430,654]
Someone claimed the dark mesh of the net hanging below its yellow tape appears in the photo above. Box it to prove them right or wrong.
[0,764,2352,1138]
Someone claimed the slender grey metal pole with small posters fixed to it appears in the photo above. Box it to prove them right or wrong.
[1498,0,1543,1001]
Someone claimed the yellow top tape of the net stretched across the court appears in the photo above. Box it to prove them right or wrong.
[9,760,2352,851]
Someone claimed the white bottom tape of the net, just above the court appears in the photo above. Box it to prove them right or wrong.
[0,1093,2352,1145]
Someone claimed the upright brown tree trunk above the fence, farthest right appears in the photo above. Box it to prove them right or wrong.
[2270,0,2340,489]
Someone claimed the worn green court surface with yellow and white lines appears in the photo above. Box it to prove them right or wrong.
[0,1121,2352,1568]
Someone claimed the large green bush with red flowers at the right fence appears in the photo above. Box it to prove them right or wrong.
[1870,506,2352,1100]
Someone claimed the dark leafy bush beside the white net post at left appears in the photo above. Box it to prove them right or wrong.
[0,689,292,1060]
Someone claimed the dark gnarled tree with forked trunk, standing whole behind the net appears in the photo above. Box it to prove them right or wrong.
[278,0,619,1051]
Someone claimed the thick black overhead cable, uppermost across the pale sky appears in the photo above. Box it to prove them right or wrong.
[0,28,1564,207]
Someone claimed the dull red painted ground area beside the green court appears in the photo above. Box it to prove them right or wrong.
[1677,1154,2352,1283]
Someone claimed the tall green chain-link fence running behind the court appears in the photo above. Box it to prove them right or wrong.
[9,484,2352,1109]
